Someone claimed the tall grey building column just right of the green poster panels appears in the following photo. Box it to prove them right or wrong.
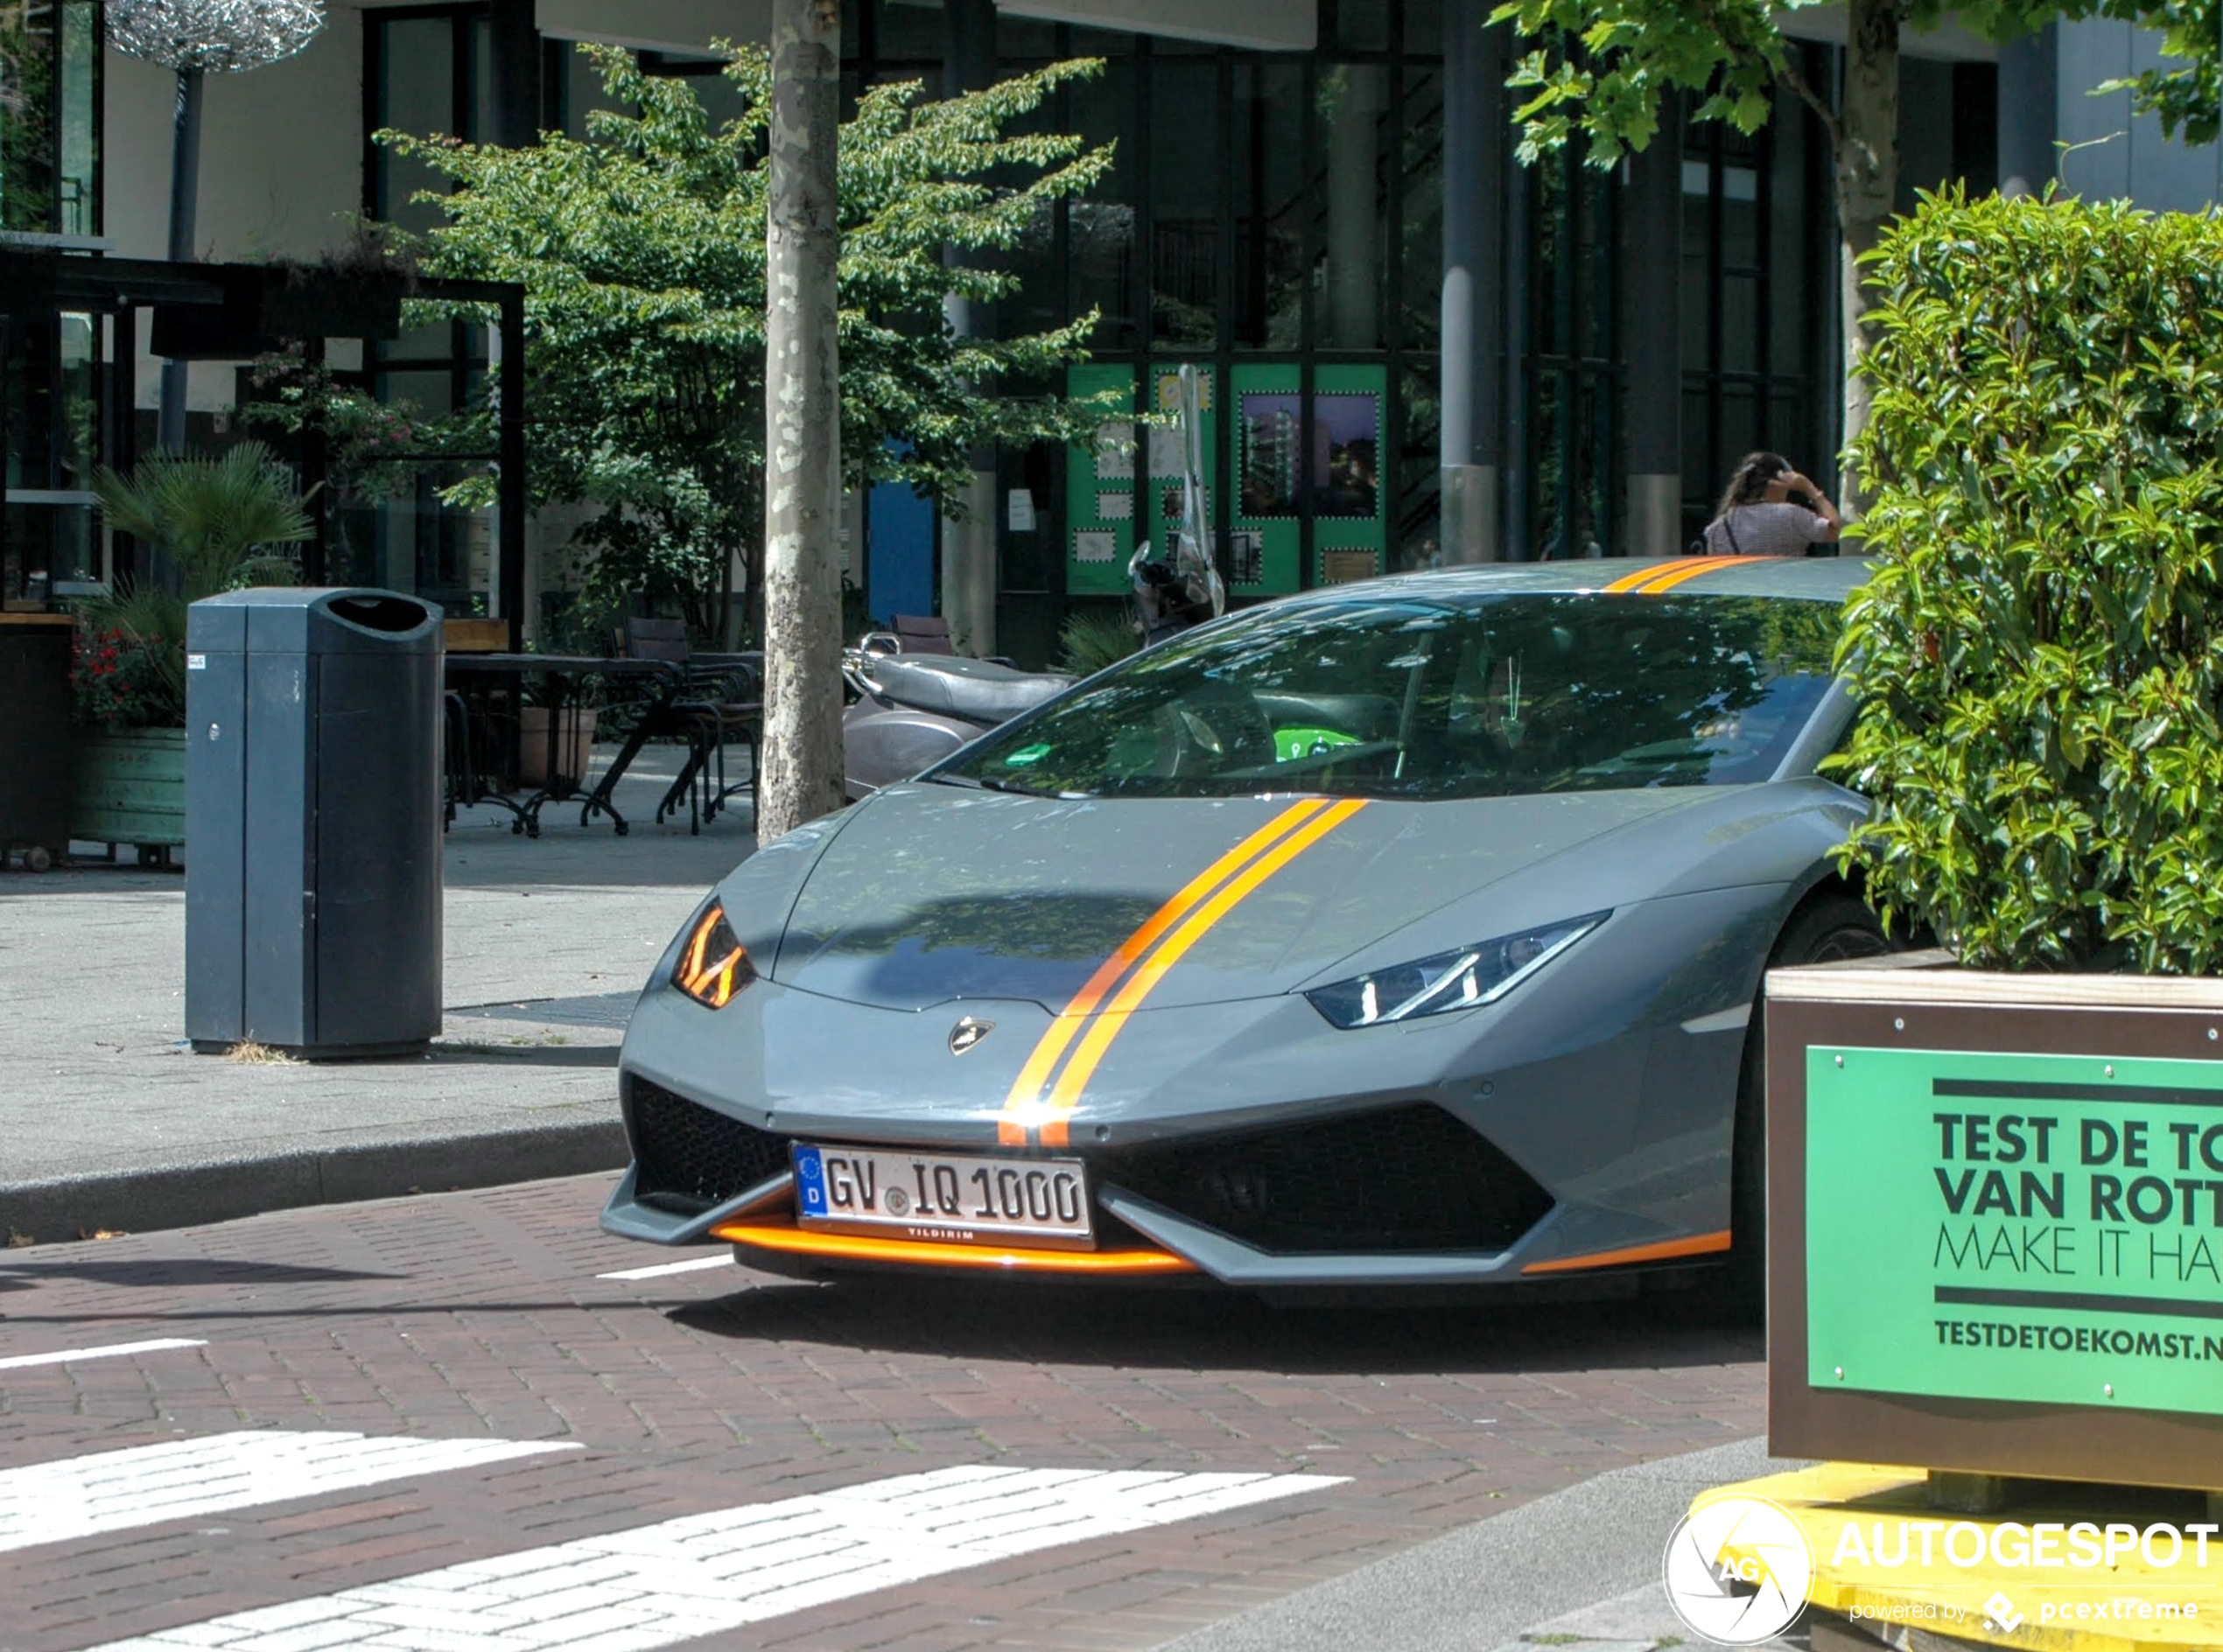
[1438,0,1507,563]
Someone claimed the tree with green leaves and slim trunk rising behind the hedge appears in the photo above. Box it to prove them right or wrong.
[1490,0,2223,491]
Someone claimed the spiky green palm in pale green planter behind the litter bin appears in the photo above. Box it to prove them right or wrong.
[69,443,313,858]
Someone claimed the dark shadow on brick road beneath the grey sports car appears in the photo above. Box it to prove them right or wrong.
[671,1278,1767,1376]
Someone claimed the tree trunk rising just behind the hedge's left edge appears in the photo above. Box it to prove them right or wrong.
[1836,0,1903,516]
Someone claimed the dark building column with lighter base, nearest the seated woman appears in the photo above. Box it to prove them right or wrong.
[1618,114,1683,556]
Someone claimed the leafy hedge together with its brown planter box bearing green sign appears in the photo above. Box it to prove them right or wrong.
[1765,192,2223,1505]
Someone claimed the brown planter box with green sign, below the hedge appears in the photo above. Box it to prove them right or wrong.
[1767,961,2223,1492]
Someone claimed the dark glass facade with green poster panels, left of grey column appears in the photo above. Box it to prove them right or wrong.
[845,0,1442,658]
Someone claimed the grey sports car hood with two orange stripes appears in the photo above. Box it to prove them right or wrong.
[771,785,1725,1012]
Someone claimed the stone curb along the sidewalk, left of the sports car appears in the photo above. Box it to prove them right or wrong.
[0,1118,631,1242]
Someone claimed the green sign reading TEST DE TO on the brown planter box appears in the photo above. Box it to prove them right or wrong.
[1805,1047,2223,1414]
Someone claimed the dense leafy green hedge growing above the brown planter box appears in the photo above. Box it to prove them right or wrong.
[1836,193,2223,974]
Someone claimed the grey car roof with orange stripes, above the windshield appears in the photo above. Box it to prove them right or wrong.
[1296,556,1869,605]
